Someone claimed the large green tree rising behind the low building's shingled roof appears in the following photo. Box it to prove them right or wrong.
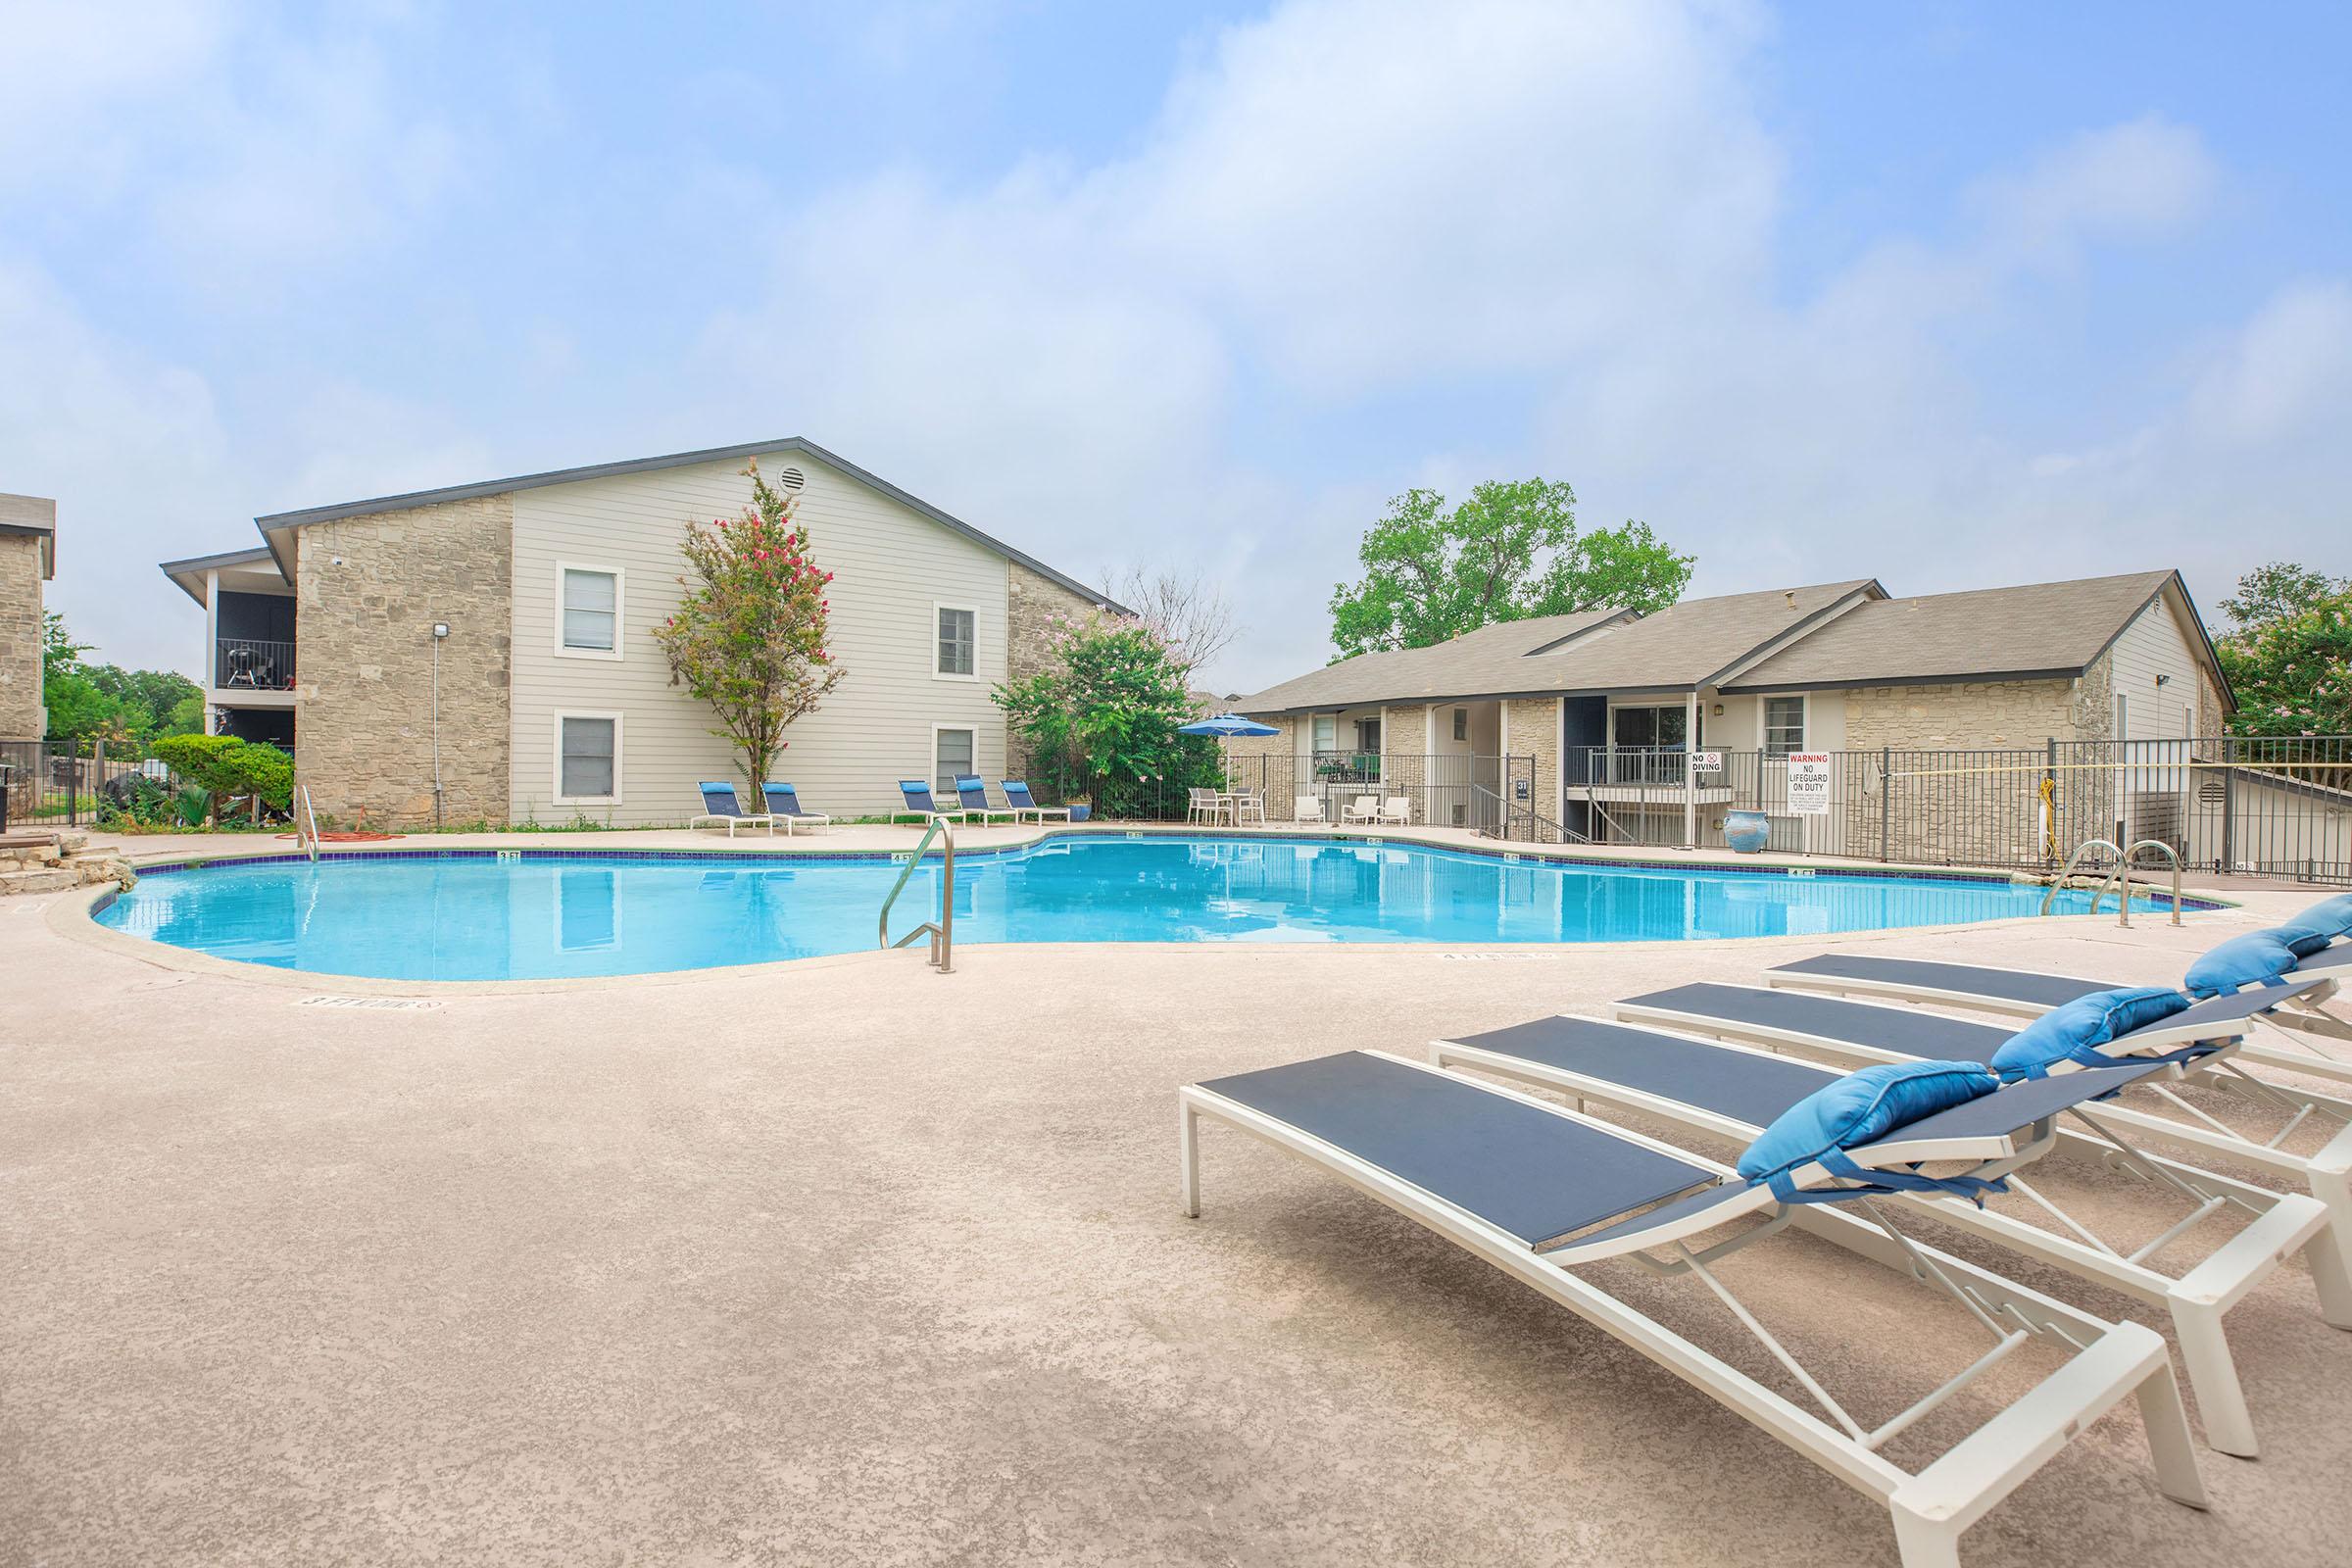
[1331,479,1695,659]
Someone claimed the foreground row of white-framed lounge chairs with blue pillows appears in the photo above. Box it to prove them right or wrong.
[1178,898,2352,1568]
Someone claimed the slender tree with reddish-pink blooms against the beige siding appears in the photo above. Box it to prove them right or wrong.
[654,459,845,802]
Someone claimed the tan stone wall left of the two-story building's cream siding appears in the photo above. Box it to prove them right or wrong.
[294,496,515,827]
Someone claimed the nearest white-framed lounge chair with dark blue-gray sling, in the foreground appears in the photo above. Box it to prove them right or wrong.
[1178,1051,2206,1568]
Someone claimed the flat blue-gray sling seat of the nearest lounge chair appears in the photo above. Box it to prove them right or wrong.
[1201,1051,1715,1246]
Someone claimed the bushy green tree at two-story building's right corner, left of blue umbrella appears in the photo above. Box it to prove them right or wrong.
[993,615,1218,815]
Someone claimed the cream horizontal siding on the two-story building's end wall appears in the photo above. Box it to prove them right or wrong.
[513,454,1006,823]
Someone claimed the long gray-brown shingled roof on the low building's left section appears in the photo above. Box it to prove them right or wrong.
[1235,578,1880,712]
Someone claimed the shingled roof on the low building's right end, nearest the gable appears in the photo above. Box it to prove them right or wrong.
[1724,571,2176,691]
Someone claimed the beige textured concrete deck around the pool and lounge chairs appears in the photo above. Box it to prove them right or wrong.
[0,879,2352,1568]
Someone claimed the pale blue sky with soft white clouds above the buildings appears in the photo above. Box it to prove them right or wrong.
[0,0,2352,689]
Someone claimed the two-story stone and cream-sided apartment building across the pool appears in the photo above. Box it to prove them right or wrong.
[163,437,1119,825]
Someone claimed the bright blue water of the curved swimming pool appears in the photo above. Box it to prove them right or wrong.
[99,835,2154,980]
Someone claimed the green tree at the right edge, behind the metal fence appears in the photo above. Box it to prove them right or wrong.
[2213,564,2352,736]
